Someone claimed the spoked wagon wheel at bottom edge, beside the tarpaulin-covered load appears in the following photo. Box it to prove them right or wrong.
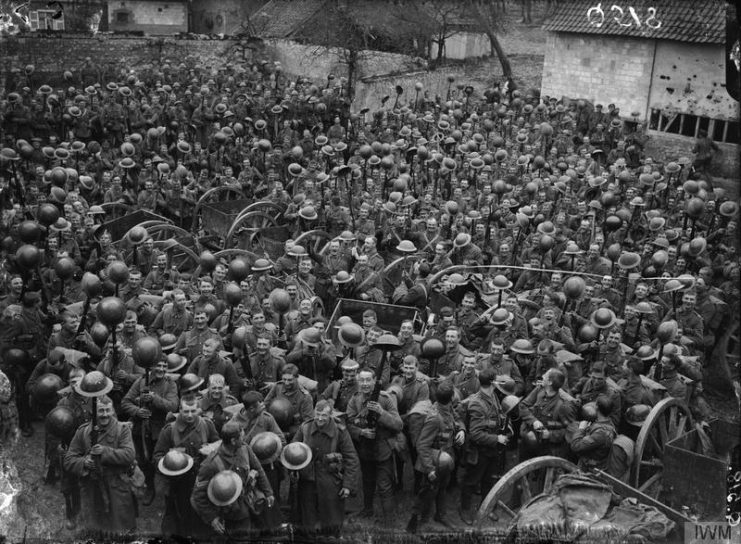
[476,455,577,528]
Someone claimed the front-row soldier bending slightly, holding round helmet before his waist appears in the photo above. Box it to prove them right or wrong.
[190,421,275,538]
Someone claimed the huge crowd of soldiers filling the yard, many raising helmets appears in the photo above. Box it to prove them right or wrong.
[0,55,740,538]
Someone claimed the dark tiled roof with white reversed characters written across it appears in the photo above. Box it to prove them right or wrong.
[543,0,726,43]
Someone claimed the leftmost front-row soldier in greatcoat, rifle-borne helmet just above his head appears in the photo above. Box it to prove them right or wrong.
[64,394,136,535]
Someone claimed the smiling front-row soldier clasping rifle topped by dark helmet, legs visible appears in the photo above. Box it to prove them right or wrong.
[347,369,403,527]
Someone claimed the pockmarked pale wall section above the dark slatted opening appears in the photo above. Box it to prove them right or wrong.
[648,42,739,120]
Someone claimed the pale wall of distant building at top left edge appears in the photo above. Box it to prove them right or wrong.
[108,0,188,34]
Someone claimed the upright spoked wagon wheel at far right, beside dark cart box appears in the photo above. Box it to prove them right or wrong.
[631,397,694,494]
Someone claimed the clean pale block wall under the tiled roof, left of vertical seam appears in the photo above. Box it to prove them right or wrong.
[542,32,654,119]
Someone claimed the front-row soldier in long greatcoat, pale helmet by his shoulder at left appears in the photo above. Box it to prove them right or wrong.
[293,400,360,538]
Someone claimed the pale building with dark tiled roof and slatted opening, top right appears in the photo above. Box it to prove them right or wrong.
[542,0,739,177]
